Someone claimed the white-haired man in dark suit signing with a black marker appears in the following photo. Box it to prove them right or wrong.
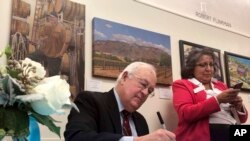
[64,62,175,141]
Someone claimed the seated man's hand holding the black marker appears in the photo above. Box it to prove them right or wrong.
[134,129,175,141]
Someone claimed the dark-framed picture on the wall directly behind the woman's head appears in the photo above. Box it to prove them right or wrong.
[179,40,224,81]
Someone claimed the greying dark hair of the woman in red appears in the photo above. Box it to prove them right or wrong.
[181,49,218,79]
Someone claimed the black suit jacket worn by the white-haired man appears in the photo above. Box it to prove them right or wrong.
[64,89,149,141]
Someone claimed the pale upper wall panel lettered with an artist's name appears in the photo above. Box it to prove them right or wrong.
[134,0,250,38]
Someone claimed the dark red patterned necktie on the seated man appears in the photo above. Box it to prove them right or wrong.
[122,110,132,136]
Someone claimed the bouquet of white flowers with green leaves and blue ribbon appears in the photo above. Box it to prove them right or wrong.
[0,47,78,140]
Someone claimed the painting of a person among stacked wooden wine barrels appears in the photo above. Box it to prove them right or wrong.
[10,0,85,97]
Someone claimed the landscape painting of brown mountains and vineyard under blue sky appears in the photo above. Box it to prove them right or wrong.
[92,18,173,85]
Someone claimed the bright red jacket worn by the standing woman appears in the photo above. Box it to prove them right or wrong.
[172,79,247,141]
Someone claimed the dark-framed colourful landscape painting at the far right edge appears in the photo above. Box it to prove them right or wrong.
[224,51,250,91]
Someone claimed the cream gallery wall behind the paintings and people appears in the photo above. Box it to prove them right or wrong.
[0,0,250,141]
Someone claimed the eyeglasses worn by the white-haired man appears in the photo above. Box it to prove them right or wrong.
[131,74,154,96]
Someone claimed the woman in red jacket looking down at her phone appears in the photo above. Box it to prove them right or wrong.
[172,49,248,141]
